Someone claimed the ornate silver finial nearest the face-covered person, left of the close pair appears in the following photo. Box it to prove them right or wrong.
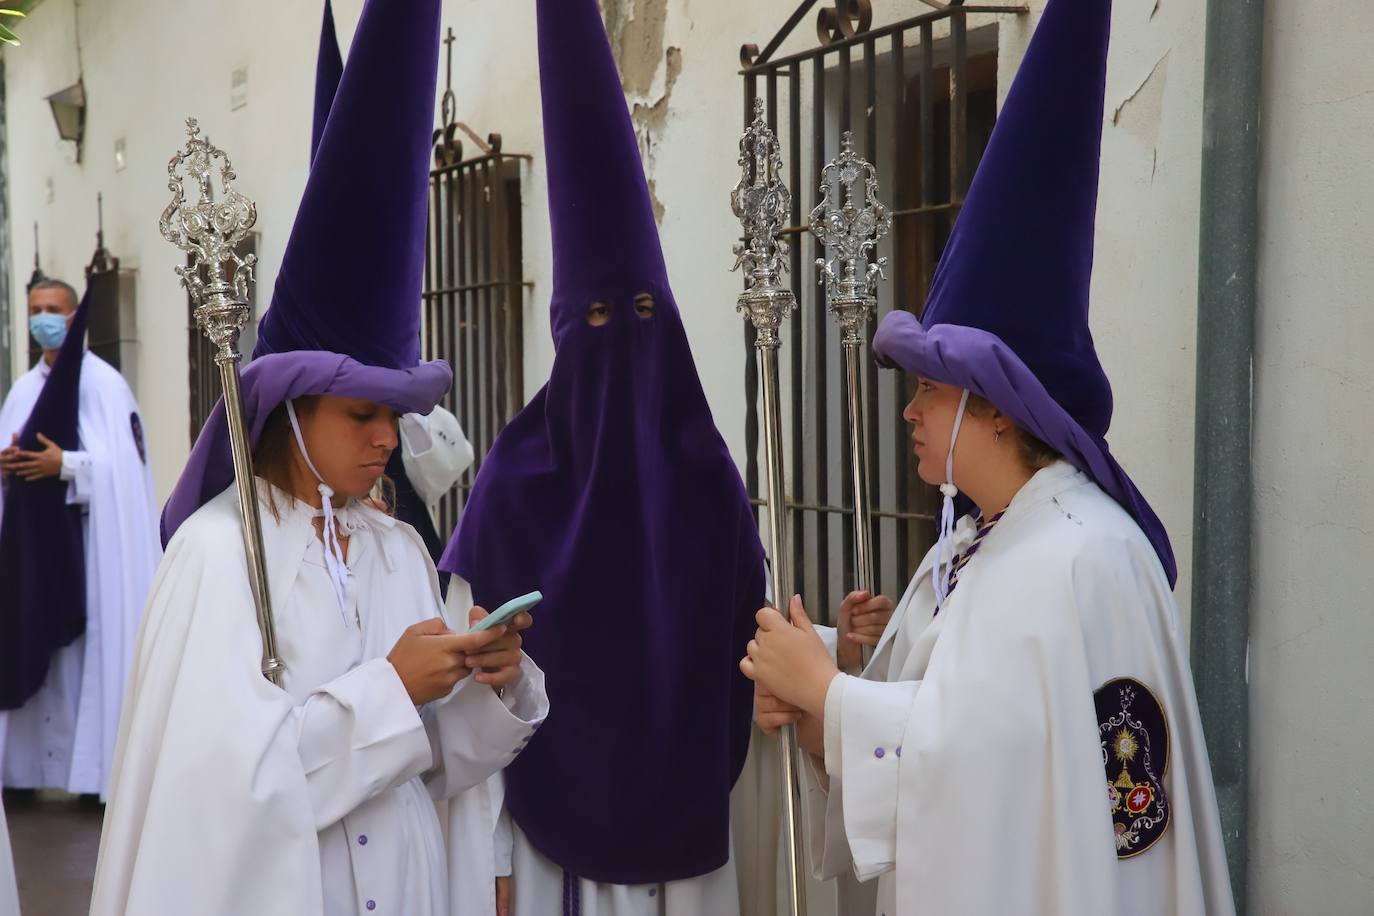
[730,99,797,347]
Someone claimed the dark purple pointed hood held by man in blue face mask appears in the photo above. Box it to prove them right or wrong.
[0,291,91,710]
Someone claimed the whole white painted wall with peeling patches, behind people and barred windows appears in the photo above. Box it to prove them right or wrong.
[3,0,1374,913]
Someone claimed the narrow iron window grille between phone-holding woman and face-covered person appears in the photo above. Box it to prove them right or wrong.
[423,119,530,538]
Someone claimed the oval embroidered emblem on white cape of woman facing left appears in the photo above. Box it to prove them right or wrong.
[1092,677,1169,858]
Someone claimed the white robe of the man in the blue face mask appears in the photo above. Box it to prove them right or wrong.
[0,352,162,795]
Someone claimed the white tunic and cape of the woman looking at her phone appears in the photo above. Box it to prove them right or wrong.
[91,488,547,916]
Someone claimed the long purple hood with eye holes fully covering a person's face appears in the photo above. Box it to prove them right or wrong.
[440,0,764,884]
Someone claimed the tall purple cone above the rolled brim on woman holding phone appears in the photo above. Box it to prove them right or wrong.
[253,0,440,368]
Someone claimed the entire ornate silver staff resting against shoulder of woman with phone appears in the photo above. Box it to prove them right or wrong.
[158,118,286,687]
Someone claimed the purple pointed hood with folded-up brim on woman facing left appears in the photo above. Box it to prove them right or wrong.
[872,0,1178,584]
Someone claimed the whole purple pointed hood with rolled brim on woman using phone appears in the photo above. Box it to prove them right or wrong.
[162,0,453,545]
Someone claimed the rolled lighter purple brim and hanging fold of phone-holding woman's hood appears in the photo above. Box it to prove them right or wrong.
[162,350,453,547]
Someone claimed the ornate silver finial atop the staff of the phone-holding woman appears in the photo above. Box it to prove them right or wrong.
[158,118,257,361]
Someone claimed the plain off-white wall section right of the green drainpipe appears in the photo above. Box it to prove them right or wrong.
[1250,0,1374,913]
